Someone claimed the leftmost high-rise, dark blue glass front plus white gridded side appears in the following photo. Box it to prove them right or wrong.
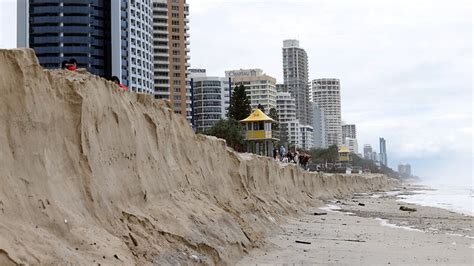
[17,0,154,94]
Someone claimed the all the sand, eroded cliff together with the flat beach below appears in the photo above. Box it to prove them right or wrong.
[0,49,474,265]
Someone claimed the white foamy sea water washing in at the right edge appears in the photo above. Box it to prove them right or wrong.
[399,182,474,216]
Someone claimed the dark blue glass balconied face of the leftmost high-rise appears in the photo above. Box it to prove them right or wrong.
[18,0,112,76]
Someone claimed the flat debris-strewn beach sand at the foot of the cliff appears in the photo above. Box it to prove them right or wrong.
[238,188,474,265]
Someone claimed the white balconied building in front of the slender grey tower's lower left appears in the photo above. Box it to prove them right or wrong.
[277,92,302,148]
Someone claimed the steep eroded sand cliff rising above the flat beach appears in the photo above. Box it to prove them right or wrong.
[0,49,393,265]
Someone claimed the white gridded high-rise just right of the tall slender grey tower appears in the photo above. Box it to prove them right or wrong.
[312,78,342,147]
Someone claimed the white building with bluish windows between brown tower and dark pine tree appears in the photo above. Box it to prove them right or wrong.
[189,69,230,133]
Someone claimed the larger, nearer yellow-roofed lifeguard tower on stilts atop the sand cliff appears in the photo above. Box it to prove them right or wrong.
[240,108,279,156]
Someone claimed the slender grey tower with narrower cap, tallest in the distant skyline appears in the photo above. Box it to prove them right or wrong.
[283,40,312,125]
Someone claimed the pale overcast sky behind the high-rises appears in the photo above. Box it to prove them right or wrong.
[0,0,474,180]
